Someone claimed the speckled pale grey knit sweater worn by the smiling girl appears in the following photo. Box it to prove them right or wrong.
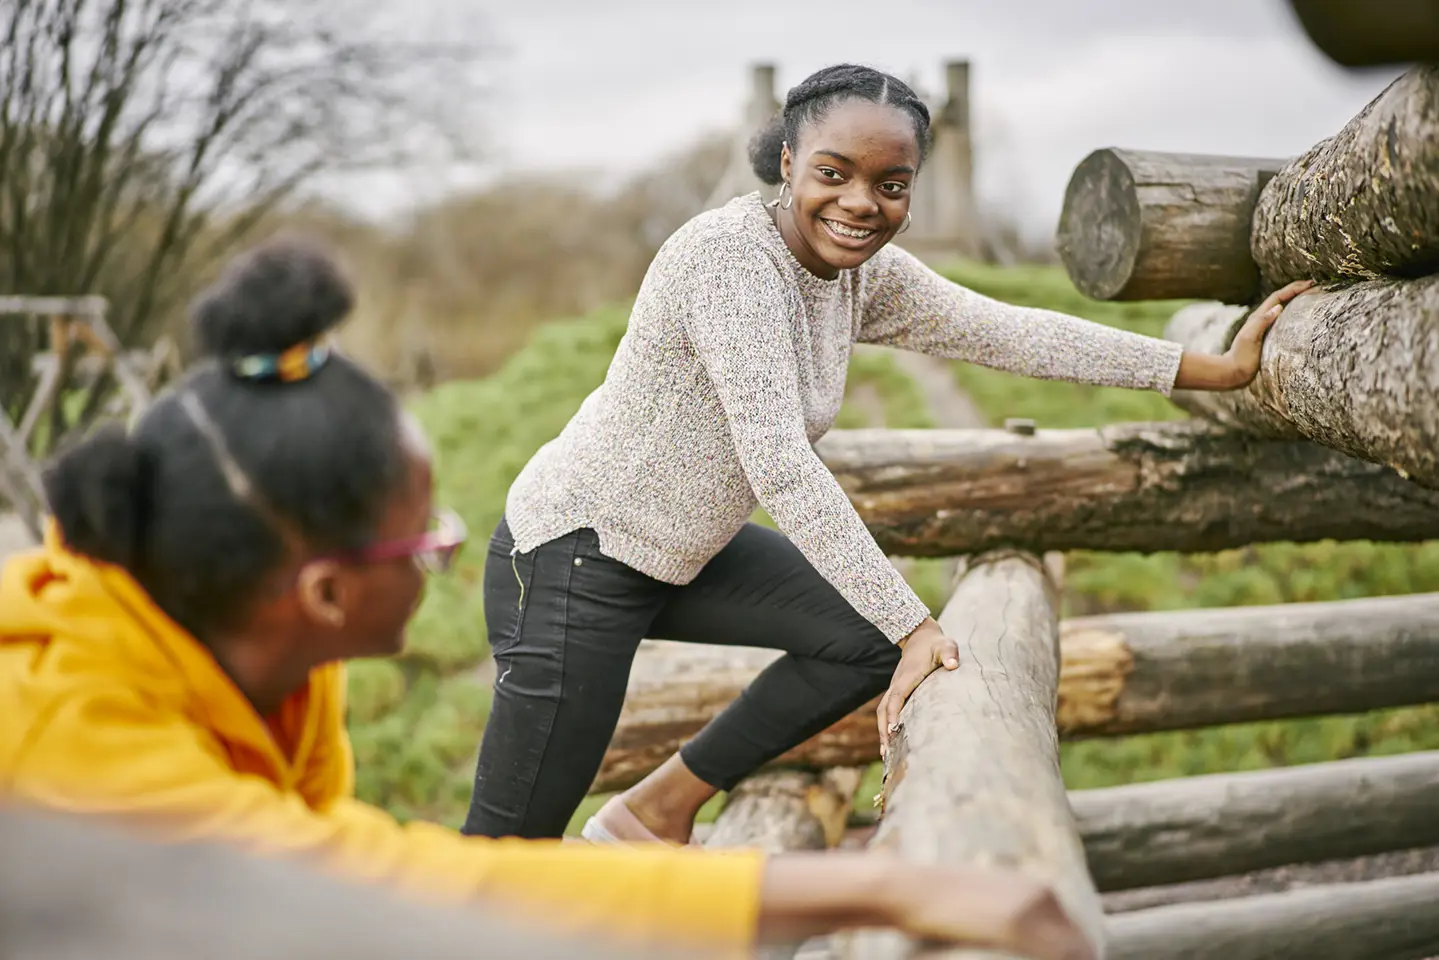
[507,193,1180,640]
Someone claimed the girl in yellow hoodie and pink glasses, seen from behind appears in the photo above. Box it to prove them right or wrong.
[0,234,1094,960]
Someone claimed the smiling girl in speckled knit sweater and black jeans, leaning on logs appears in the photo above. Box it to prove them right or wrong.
[465,65,1318,843]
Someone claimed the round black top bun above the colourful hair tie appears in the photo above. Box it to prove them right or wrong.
[190,237,354,364]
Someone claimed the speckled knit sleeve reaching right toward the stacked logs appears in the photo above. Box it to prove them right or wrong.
[859,246,1183,396]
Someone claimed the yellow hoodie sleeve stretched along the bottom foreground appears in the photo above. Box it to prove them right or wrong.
[4,689,764,954]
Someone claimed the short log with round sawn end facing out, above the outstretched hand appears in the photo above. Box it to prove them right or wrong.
[1056,148,1286,304]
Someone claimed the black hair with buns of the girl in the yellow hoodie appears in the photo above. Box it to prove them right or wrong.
[45,237,406,640]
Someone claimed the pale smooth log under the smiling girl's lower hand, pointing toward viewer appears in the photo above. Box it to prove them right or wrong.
[845,553,1104,960]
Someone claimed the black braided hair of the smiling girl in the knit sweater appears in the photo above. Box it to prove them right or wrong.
[750,63,931,184]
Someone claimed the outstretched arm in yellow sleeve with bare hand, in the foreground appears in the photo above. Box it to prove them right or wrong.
[4,689,1094,960]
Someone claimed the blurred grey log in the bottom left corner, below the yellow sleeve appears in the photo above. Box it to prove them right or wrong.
[0,810,659,960]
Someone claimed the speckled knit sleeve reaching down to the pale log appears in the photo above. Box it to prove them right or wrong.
[672,235,930,640]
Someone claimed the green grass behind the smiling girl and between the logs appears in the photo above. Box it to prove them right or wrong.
[350,265,1439,825]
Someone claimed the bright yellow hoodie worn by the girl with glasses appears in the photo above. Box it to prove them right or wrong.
[0,528,763,954]
